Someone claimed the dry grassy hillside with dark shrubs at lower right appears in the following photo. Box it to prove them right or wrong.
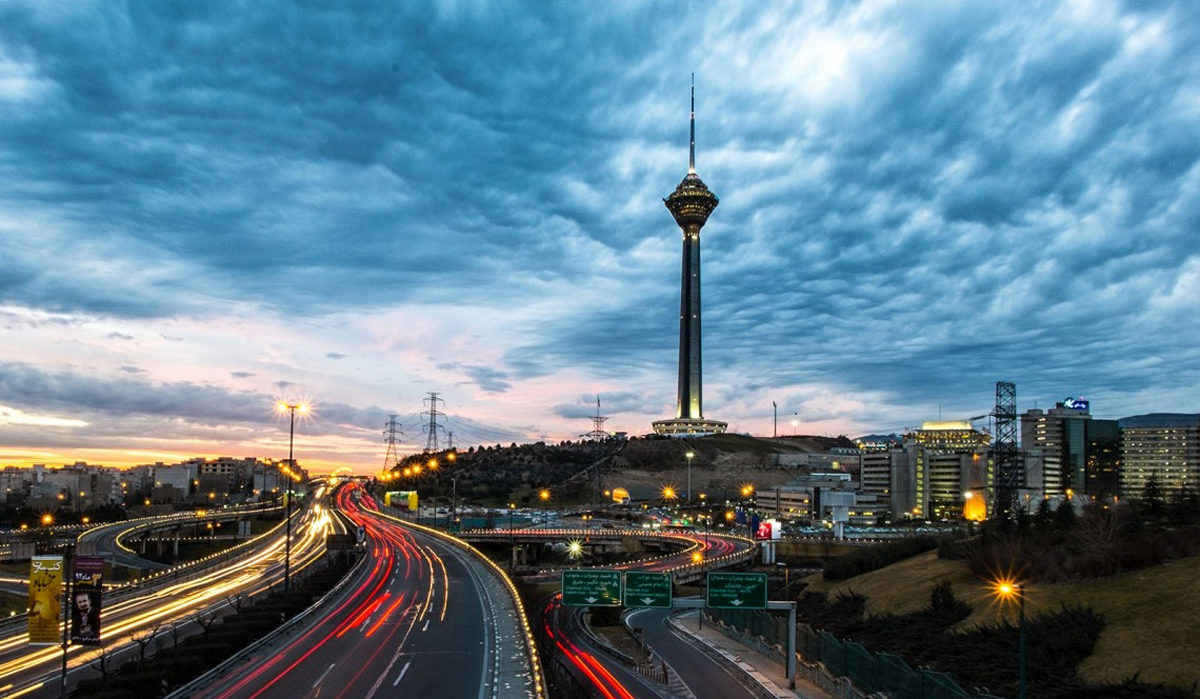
[800,551,1200,686]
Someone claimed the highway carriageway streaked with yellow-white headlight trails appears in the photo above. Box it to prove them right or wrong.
[0,503,336,699]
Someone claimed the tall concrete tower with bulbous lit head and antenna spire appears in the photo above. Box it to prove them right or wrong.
[654,80,727,436]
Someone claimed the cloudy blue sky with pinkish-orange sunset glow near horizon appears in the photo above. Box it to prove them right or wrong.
[0,0,1200,472]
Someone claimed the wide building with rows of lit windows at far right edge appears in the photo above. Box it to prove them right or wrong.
[1120,413,1200,498]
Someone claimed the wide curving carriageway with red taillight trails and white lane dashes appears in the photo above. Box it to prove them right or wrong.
[183,484,542,699]
